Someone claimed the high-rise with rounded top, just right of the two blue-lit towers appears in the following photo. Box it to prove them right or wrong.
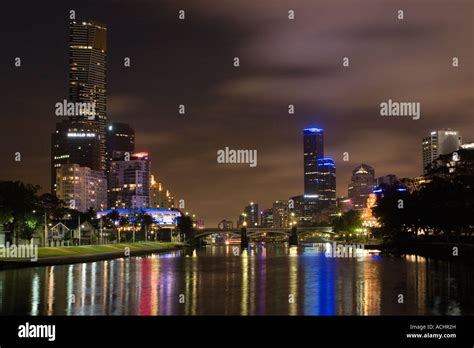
[348,164,375,209]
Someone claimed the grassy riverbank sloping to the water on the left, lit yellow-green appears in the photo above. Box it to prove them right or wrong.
[0,242,184,269]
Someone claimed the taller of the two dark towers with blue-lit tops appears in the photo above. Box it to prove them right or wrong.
[303,127,324,198]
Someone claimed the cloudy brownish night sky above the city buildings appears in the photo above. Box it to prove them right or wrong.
[0,0,474,226]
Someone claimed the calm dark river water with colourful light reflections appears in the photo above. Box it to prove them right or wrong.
[0,244,474,315]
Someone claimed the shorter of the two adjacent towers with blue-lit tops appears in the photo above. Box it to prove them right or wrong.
[316,158,336,210]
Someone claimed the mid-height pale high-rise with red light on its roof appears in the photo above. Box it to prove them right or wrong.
[109,152,151,208]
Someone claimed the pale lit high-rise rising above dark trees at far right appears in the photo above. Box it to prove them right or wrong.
[422,128,462,174]
